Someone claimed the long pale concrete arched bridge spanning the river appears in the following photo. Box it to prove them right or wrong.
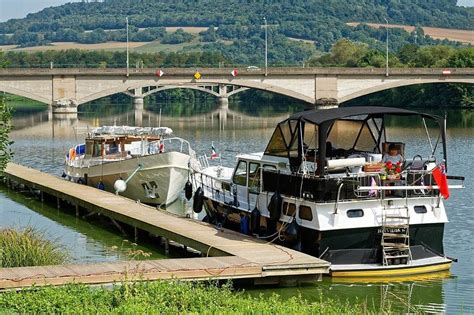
[0,68,474,112]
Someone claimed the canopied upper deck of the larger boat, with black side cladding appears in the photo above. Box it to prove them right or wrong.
[262,107,447,200]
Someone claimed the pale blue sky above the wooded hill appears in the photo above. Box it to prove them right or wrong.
[0,0,474,21]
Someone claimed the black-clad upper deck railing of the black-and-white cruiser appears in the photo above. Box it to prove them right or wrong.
[262,170,464,205]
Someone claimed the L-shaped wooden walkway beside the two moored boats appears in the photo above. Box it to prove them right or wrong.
[0,163,329,289]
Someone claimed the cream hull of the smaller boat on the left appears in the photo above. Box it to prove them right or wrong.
[65,152,190,205]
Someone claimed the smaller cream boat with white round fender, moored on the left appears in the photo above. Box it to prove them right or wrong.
[64,126,194,205]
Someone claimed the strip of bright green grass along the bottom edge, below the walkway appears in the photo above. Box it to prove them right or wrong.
[0,281,379,314]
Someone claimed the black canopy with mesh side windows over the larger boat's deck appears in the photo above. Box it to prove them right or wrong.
[265,106,446,175]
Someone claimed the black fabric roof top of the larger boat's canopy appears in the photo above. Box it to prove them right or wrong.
[286,106,440,125]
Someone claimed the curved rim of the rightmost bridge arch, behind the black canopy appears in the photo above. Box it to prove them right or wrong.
[338,79,474,104]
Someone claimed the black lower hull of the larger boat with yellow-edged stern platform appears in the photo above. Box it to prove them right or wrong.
[204,198,452,278]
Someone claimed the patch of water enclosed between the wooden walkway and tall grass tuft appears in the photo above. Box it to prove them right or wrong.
[0,186,165,263]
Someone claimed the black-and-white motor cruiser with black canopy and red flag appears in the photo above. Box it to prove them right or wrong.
[192,107,464,277]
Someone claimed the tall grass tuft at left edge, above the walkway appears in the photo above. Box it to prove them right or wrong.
[0,227,68,268]
